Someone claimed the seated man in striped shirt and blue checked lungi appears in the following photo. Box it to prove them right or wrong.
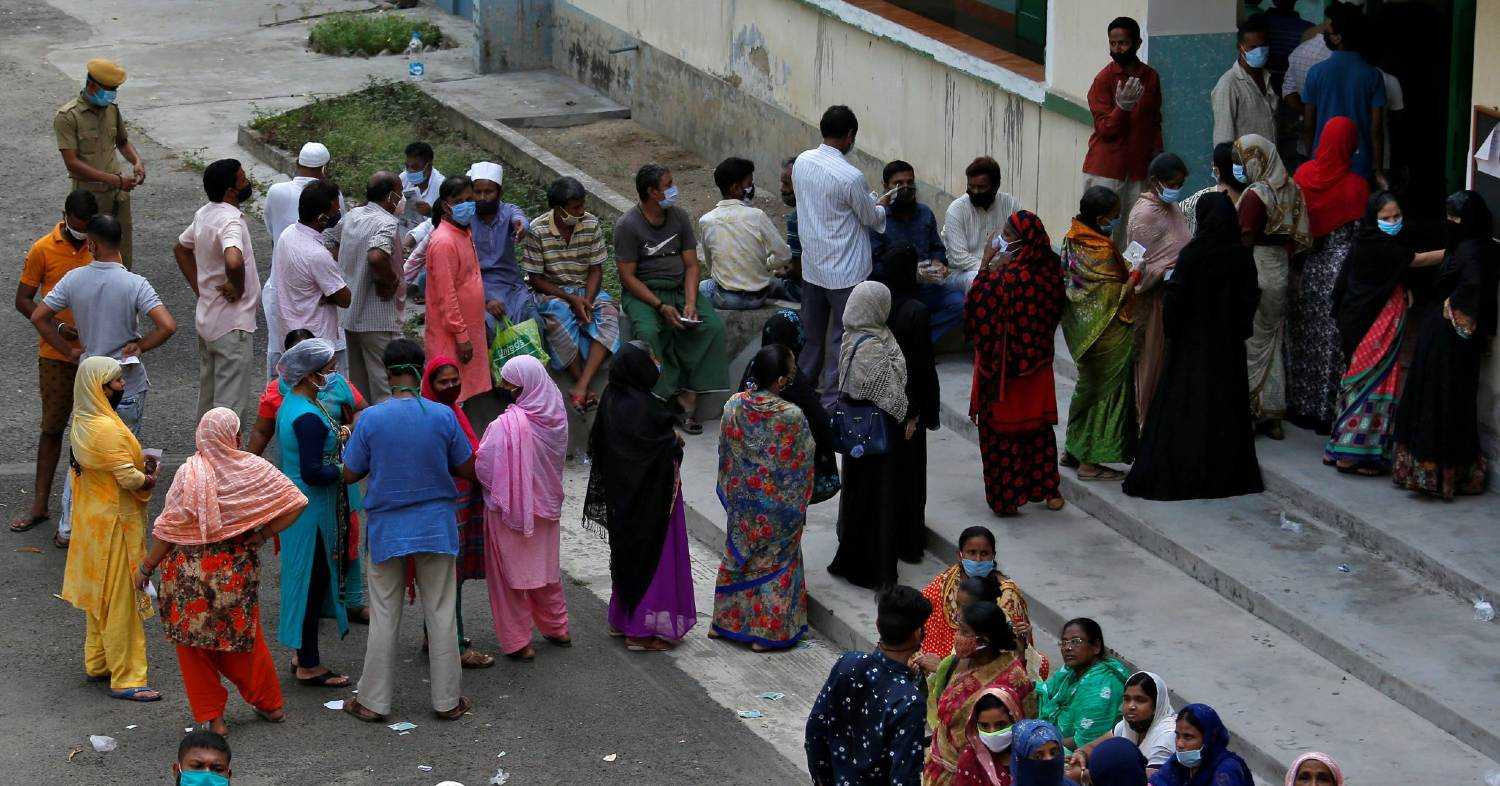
[521,177,620,410]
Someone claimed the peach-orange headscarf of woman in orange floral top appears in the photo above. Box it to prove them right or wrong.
[152,407,308,546]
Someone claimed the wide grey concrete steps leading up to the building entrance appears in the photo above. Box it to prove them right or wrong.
[683,339,1500,783]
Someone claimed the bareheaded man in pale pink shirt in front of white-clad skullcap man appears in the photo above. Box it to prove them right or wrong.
[272,180,351,375]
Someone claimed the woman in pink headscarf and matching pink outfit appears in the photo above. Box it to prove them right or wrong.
[474,356,573,660]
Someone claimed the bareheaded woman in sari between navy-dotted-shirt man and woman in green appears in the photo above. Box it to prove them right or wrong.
[923,602,1037,786]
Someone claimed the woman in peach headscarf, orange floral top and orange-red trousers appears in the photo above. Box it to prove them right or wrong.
[135,407,308,734]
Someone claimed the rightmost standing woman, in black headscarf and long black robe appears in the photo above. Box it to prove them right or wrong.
[1392,191,1500,500]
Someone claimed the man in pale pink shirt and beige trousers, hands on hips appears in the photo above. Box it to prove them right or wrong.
[173,159,261,422]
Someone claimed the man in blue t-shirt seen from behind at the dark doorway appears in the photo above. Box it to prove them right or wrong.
[1302,14,1388,188]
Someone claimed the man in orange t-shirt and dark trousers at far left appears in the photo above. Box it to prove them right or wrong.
[11,189,99,548]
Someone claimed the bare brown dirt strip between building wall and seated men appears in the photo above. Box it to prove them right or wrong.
[516,120,789,227]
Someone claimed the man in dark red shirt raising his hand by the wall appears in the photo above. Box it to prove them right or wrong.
[1083,17,1163,246]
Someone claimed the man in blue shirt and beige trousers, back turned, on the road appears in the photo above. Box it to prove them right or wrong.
[344,339,476,723]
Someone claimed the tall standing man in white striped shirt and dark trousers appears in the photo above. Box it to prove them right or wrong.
[792,105,891,404]
